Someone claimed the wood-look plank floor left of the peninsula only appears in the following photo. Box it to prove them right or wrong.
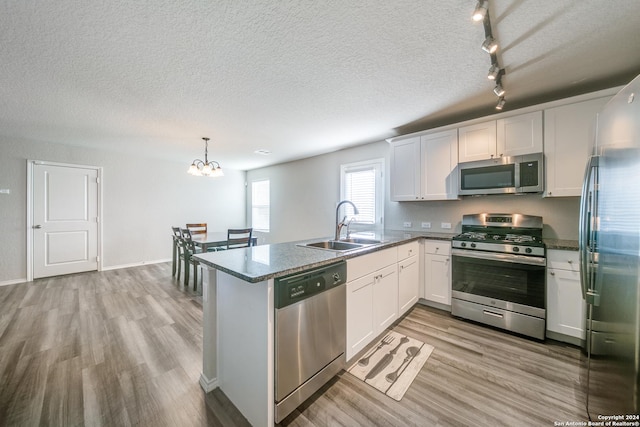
[0,263,248,426]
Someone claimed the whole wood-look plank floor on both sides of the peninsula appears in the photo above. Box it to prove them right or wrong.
[0,263,585,427]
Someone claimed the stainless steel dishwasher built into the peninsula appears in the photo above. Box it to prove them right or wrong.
[274,261,347,423]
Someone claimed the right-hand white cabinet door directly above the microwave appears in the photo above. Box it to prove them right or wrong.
[496,111,542,157]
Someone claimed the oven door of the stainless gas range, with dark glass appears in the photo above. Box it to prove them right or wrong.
[451,249,546,318]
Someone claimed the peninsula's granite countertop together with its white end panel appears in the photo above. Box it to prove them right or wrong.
[197,232,451,426]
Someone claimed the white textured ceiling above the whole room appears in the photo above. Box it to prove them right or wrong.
[0,0,640,169]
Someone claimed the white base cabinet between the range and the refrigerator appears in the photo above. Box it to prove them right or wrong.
[547,249,586,340]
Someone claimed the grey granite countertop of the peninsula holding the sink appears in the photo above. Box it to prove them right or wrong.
[194,230,455,283]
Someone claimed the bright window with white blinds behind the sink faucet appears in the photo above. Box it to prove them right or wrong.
[340,159,384,228]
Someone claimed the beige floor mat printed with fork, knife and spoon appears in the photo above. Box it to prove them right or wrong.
[347,331,433,400]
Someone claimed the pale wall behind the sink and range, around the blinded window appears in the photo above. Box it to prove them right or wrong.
[247,141,579,243]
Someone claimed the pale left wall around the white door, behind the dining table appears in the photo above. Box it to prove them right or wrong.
[0,138,246,284]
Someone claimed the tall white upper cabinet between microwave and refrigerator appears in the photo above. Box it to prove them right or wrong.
[544,96,611,197]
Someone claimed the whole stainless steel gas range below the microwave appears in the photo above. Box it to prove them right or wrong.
[451,213,547,340]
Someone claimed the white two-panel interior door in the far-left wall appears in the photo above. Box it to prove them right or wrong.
[31,162,98,279]
